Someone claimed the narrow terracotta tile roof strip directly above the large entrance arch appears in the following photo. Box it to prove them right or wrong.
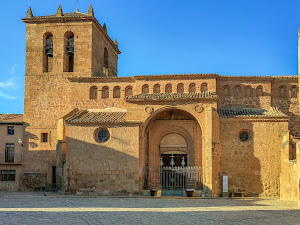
[125,91,217,102]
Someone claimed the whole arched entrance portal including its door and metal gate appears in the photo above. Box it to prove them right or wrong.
[143,109,202,195]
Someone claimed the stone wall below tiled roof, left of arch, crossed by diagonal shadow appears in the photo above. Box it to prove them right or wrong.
[66,124,141,194]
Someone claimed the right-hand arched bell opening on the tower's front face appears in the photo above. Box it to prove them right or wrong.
[64,31,75,72]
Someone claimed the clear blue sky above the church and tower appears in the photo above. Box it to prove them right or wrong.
[0,0,300,113]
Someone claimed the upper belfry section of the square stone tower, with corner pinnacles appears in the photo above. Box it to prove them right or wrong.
[22,5,121,77]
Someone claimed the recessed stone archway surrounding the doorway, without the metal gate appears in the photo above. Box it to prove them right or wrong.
[143,109,202,193]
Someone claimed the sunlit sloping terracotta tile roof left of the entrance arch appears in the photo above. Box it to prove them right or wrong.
[65,110,127,124]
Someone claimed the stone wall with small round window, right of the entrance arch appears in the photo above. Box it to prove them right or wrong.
[220,119,288,196]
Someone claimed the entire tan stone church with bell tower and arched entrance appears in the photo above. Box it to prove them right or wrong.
[1,6,300,201]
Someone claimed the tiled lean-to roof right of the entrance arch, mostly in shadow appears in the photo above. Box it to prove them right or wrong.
[218,107,288,118]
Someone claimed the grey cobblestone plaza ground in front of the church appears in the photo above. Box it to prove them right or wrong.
[0,192,300,225]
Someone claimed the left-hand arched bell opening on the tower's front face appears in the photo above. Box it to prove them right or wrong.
[43,32,53,72]
